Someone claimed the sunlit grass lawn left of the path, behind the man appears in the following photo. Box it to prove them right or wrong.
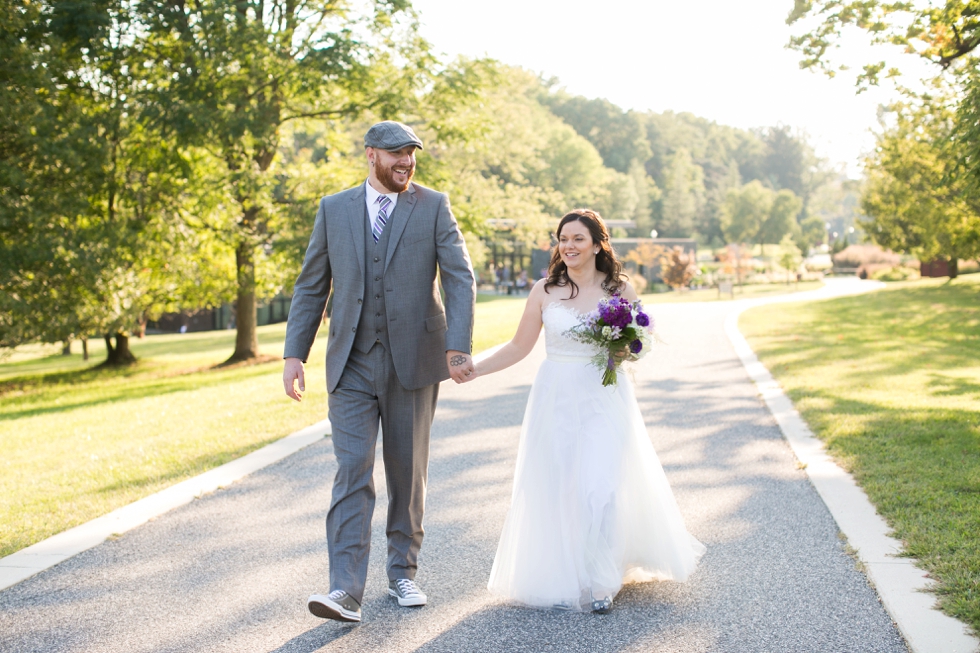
[0,297,525,556]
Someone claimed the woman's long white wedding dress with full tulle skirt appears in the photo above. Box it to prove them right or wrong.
[488,302,705,611]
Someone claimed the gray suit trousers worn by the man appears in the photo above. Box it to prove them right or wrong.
[327,344,439,603]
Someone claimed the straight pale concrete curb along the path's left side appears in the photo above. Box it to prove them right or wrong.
[0,420,330,590]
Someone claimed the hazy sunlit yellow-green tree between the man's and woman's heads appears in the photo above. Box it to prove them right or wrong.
[418,61,636,246]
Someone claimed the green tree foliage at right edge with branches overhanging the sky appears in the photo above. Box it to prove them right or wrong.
[787,0,980,276]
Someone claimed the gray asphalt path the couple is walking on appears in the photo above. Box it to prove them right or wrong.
[0,282,907,653]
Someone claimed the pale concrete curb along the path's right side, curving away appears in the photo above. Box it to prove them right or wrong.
[725,298,980,653]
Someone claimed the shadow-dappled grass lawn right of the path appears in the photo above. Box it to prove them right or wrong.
[739,275,980,631]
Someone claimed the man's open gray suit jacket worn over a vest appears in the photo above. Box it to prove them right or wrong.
[283,183,476,392]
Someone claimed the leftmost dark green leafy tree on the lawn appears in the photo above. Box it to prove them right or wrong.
[0,0,222,365]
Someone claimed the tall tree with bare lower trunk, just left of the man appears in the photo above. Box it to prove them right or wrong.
[136,0,433,361]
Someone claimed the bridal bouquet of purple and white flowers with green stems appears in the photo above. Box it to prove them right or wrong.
[568,295,654,386]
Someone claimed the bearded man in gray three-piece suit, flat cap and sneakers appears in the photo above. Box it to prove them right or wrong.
[283,121,476,621]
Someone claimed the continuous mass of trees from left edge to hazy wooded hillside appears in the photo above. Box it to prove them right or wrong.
[0,0,856,363]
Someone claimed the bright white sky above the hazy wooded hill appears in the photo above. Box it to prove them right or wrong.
[412,0,928,177]
